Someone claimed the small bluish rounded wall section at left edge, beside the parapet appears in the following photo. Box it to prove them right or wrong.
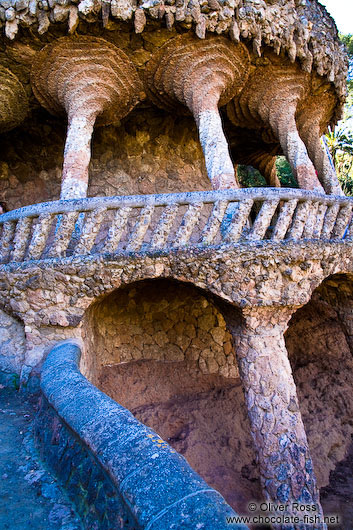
[0,309,25,385]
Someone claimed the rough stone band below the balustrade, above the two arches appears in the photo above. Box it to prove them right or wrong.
[0,242,353,367]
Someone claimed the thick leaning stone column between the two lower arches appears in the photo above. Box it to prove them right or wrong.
[230,308,326,529]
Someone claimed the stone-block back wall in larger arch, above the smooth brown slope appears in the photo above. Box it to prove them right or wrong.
[83,280,238,378]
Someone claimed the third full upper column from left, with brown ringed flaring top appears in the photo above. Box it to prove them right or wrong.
[227,54,324,193]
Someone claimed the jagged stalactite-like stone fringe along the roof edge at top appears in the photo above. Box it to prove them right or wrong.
[0,0,348,119]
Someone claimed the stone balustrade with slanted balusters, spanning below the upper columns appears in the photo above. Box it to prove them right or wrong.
[0,188,353,264]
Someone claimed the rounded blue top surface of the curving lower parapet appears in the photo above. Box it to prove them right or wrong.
[41,339,242,530]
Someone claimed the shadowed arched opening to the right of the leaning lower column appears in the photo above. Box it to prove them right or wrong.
[286,274,353,529]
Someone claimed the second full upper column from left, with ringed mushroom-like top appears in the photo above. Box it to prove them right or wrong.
[145,35,250,189]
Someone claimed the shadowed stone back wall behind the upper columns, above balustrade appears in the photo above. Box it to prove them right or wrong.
[0,108,211,209]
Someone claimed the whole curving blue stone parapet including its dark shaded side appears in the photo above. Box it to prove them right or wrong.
[36,341,247,530]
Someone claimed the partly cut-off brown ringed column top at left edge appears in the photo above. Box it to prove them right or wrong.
[0,66,28,132]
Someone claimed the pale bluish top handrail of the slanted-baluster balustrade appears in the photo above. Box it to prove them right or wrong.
[0,188,353,224]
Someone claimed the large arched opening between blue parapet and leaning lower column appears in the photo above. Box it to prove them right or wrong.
[83,280,261,512]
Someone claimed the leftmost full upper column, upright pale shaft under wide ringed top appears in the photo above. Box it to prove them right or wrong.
[31,37,142,199]
